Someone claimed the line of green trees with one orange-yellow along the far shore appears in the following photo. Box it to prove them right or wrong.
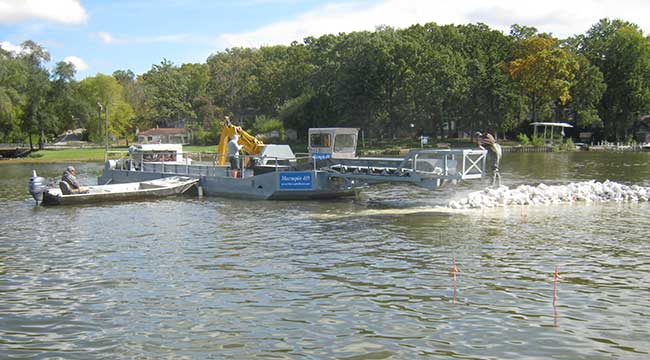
[0,19,650,146]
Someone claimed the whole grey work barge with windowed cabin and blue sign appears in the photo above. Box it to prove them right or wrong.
[98,127,486,200]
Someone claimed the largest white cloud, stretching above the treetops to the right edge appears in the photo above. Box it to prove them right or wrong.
[218,0,650,47]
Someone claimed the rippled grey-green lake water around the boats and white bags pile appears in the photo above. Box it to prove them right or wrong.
[0,152,650,359]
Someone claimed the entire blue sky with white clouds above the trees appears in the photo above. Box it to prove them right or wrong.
[0,0,650,79]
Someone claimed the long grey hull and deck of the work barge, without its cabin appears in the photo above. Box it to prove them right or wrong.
[98,149,486,200]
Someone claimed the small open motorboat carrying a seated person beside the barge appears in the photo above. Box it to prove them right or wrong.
[32,176,199,205]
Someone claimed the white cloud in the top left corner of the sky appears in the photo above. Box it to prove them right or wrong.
[0,0,88,24]
